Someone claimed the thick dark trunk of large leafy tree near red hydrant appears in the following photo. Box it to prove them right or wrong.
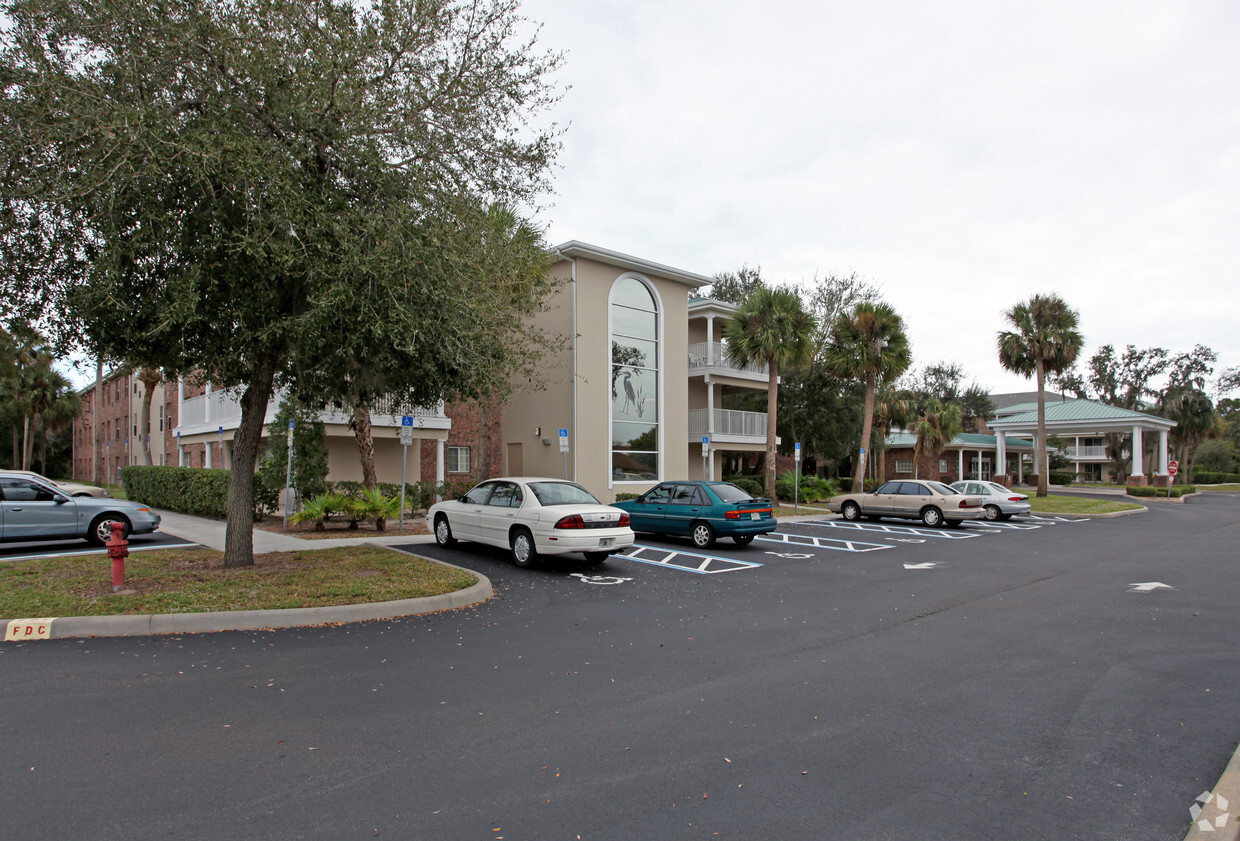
[224,358,275,567]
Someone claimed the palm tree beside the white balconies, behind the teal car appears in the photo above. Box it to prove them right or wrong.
[723,287,816,499]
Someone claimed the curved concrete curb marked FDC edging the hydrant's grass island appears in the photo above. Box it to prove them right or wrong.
[0,558,495,641]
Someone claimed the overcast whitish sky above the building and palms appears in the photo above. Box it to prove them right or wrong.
[523,0,1240,392]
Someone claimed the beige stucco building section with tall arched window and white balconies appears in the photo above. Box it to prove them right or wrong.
[502,241,768,501]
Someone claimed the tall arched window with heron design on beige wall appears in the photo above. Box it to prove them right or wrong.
[611,277,660,481]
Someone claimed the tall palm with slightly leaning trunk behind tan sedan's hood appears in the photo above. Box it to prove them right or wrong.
[826,301,913,494]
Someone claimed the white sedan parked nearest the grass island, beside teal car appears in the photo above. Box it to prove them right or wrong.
[427,478,634,567]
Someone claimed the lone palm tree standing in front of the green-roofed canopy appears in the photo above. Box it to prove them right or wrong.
[998,295,1084,496]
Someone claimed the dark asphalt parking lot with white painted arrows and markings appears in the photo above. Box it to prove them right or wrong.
[0,496,1240,841]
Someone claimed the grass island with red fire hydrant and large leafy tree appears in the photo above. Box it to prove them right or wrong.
[0,546,477,619]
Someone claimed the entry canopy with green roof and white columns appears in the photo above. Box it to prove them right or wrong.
[987,399,1176,484]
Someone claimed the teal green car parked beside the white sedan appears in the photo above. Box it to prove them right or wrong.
[613,481,779,550]
